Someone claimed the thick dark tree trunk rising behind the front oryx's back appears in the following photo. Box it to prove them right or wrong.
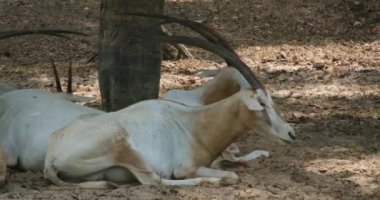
[98,0,164,111]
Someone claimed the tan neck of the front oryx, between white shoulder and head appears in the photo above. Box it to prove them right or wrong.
[188,94,254,162]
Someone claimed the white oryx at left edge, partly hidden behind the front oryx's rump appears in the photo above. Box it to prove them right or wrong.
[0,62,95,170]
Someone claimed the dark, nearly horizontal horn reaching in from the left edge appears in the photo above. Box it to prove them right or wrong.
[0,29,88,40]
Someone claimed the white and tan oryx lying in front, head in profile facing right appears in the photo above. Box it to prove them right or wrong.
[44,14,295,188]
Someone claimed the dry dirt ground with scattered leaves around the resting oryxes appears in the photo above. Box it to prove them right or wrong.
[0,0,380,200]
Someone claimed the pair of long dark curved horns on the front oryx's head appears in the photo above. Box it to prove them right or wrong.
[128,13,266,92]
